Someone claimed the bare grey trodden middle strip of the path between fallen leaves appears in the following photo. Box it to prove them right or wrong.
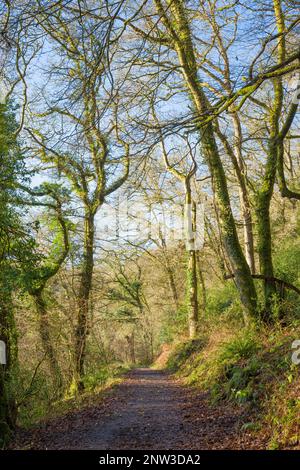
[76,369,183,449]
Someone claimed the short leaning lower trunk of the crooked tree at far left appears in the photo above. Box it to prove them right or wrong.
[33,291,63,395]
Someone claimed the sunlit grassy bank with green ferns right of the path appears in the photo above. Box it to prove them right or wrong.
[167,321,300,449]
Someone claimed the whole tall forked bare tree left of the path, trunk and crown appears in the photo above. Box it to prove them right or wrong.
[26,3,129,390]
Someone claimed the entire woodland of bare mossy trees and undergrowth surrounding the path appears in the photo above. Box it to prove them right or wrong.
[0,0,300,448]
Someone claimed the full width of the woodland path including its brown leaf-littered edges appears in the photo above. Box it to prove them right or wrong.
[15,369,261,450]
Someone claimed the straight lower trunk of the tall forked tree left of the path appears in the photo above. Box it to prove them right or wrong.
[73,212,95,392]
